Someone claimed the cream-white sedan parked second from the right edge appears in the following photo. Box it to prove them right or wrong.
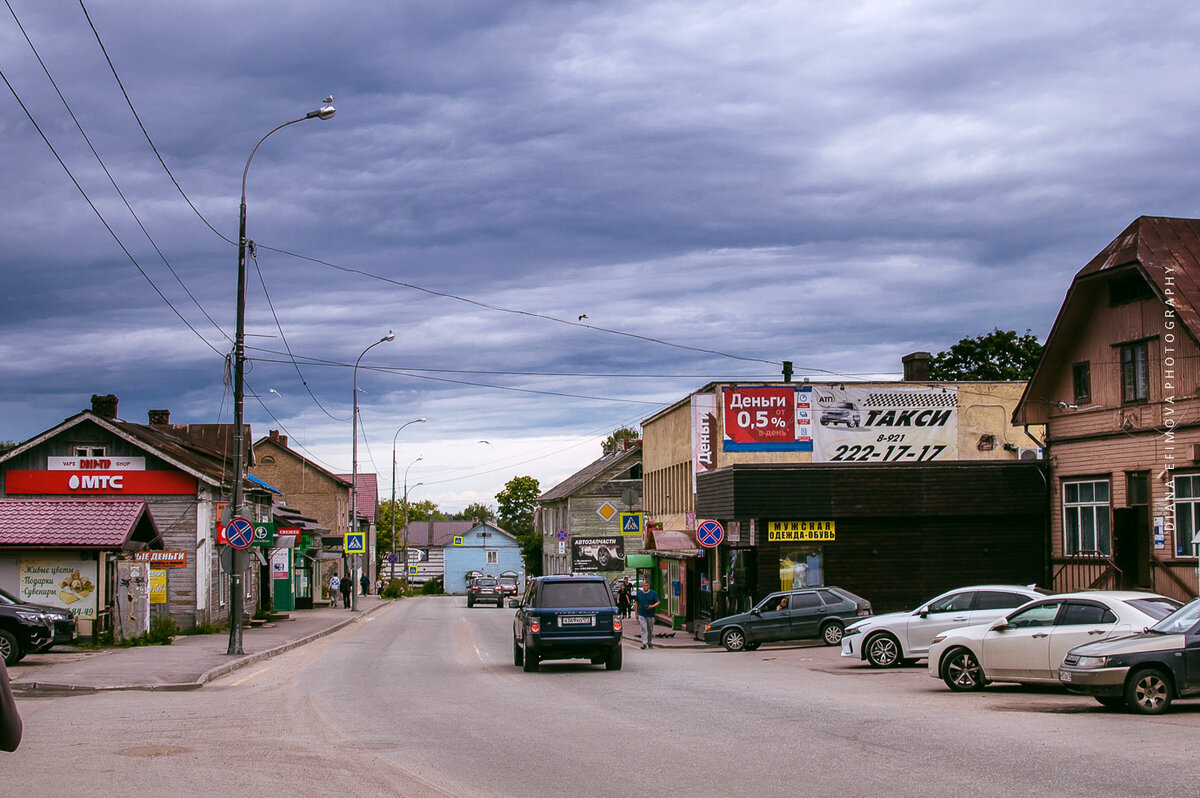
[929,590,1180,691]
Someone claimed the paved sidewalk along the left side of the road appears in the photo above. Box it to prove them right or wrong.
[10,595,392,696]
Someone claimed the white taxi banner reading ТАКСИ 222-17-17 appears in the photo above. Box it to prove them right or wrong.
[812,385,959,463]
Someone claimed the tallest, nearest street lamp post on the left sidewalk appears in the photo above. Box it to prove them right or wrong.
[226,95,337,654]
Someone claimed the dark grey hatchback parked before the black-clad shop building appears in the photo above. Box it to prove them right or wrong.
[704,587,871,652]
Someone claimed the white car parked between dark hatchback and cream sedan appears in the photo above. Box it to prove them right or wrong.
[841,584,1046,667]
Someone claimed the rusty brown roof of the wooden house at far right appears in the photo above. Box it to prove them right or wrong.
[1013,216,1200,424]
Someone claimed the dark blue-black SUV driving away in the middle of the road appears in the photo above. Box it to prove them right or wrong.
[512,575,620,672]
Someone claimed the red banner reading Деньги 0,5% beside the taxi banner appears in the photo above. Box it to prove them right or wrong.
[721,385,812,451]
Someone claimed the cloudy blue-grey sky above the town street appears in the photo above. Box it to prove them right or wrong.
[0,0,1200,510]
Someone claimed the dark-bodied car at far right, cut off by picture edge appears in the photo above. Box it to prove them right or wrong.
[1058,599,1200,715]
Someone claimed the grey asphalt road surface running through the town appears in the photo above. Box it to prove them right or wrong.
[0,598,1200,798]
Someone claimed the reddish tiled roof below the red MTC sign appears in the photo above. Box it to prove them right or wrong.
[0,497,162,551]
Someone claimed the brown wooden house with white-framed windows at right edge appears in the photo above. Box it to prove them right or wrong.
[1013,216,1200,599]
